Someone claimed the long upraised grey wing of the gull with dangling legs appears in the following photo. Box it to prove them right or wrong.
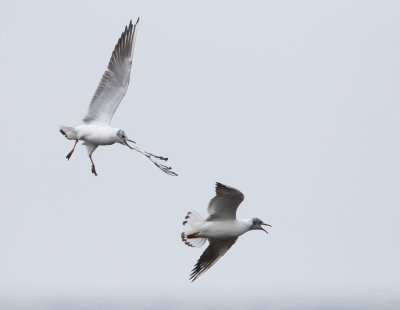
[83,18,139,124]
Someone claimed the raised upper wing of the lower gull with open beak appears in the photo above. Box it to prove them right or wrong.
[207,182,244,221]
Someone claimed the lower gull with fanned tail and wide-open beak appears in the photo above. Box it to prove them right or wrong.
[181,182,271,282]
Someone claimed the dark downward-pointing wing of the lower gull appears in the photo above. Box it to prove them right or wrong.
[190,237,238,282]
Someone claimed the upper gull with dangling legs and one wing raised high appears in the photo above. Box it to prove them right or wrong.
[59,18,177,176]
